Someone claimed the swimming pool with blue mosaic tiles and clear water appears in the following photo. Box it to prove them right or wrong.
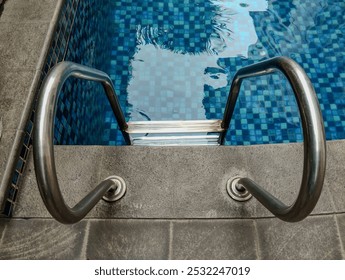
[55,0,345,145]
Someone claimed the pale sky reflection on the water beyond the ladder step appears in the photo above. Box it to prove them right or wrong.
[127,0,267,120]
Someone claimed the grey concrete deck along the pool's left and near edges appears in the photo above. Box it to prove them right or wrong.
[0,0,345,259]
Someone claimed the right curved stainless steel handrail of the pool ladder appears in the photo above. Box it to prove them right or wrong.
[220,57,326,222]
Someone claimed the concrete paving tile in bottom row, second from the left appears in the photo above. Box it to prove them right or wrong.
[87,219,169,260]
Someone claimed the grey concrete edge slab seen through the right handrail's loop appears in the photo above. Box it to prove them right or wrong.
[246,143,334,217]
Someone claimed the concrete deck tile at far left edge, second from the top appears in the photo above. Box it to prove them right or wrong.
[0,22,49,71]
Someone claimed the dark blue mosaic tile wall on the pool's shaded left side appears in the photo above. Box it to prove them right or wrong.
[54,0,114,145]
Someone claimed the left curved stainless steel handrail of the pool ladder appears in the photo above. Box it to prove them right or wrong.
[33,62,129,224]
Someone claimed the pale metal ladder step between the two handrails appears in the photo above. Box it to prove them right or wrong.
[126,120,224,146]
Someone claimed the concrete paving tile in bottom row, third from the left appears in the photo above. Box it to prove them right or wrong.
[171,220,257,260]
